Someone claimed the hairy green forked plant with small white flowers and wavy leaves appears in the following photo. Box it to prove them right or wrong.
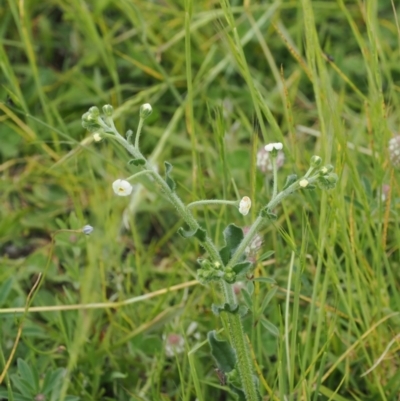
[82,104,338,401]
